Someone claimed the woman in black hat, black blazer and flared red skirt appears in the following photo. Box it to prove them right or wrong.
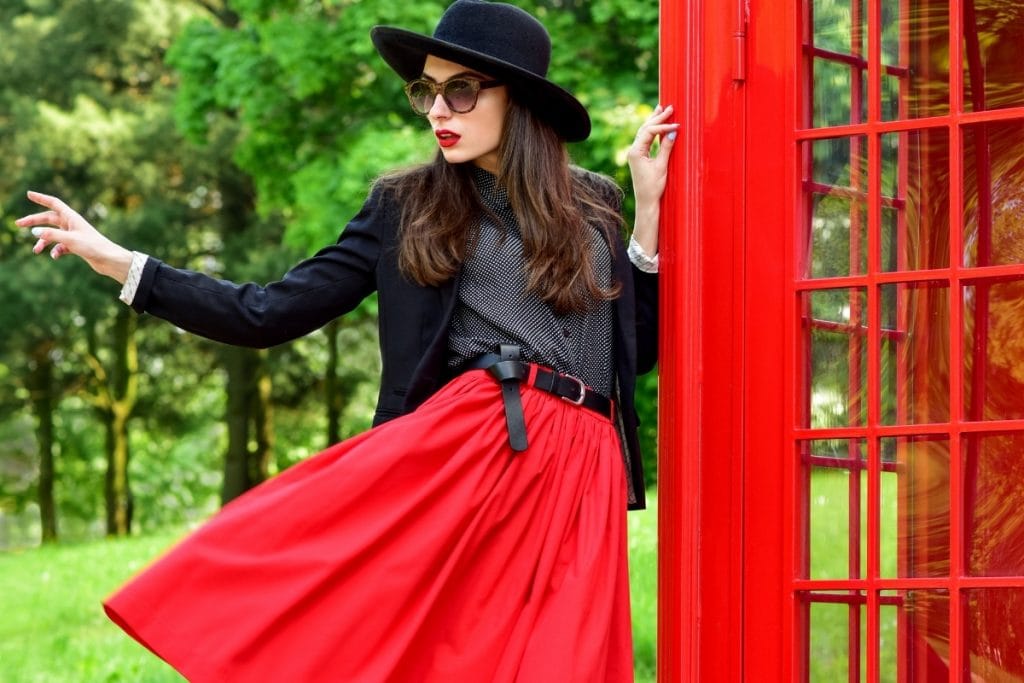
[18,0,676,682]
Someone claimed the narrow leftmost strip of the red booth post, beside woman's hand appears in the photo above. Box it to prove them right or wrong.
[657,0,700,683]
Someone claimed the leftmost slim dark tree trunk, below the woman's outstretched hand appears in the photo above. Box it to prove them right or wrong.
[29,344,57,543]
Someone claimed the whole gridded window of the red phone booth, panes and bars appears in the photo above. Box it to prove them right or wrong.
[792,0,1024,682]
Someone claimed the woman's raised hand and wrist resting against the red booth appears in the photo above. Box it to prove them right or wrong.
[626,104,679,256]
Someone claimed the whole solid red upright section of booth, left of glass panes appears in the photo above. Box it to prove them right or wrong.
[657,0,797,683]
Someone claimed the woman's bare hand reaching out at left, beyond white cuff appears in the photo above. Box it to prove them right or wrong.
[15,190,131,285]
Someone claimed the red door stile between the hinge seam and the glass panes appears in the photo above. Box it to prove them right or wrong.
[741,2,800,683]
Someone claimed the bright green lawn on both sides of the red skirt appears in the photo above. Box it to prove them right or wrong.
[0,497,657,683]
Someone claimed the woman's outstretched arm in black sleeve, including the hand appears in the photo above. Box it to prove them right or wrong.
[17,184,389,347]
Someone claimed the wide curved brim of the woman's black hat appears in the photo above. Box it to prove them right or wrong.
[370,26,591,142]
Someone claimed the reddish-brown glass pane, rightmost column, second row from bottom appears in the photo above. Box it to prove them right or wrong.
[963,433,1024,573]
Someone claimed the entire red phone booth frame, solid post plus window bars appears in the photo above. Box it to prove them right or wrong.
[658,0,1024,683]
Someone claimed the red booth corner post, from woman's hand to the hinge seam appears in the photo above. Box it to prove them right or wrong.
[657,0,749,683]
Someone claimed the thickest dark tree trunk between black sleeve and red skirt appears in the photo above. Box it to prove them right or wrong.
[220,346,273,504]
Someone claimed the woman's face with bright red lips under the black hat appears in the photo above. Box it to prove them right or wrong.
[423,55,509,173]
